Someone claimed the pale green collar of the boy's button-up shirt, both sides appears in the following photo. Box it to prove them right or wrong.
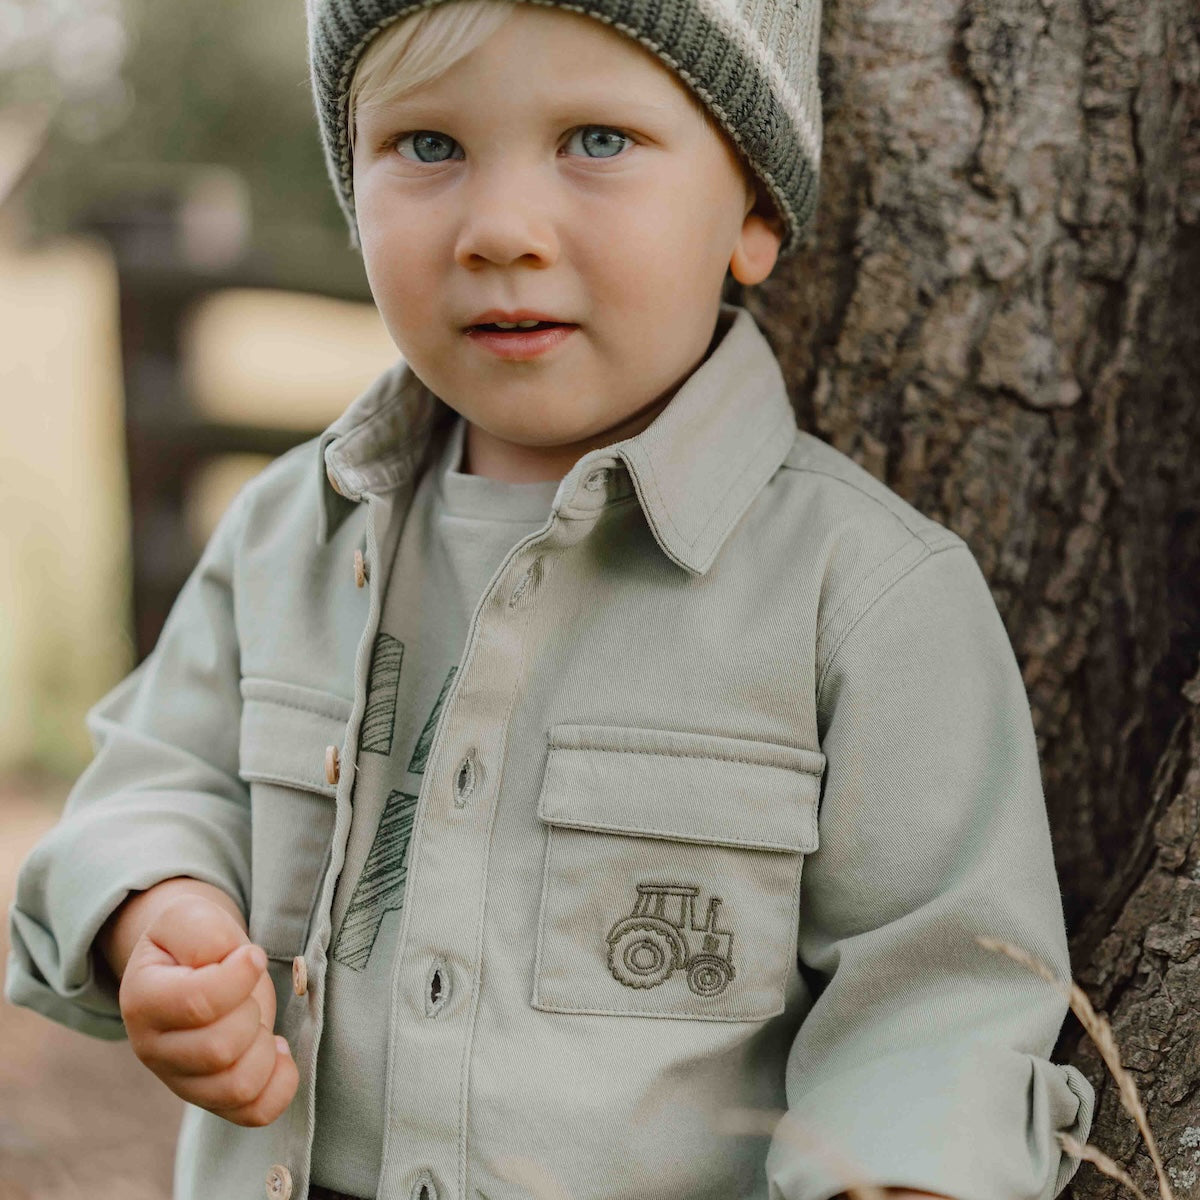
[317,302,797,575]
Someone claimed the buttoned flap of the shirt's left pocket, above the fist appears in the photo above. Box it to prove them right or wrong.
[238,677,354,796]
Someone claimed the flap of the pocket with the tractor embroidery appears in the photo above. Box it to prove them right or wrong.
[538,725,826,853]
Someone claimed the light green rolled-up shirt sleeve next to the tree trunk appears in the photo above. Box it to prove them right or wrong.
[767,542,1094,1200]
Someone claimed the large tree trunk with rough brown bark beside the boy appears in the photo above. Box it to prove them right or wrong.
[730,0,1200,1200]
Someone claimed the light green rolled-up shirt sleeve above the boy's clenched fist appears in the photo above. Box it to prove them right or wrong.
[5,488,250,1039]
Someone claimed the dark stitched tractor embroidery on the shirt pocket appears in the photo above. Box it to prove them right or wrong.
[608,883,734,996]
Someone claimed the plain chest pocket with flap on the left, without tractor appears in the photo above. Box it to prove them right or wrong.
[238,678,353,962]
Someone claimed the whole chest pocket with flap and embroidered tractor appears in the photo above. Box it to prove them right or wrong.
[532,725,824,1021]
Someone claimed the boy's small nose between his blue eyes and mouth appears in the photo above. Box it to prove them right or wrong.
[455,162,558,268]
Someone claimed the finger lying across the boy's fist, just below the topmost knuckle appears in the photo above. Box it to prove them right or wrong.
[133,942,266,1032]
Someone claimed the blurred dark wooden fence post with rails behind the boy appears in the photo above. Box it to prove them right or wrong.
[82,176,371,661]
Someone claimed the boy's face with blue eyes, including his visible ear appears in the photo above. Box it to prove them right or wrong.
[354,4,782,482]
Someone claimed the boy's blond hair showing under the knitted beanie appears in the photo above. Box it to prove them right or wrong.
[347,0,728,157]
